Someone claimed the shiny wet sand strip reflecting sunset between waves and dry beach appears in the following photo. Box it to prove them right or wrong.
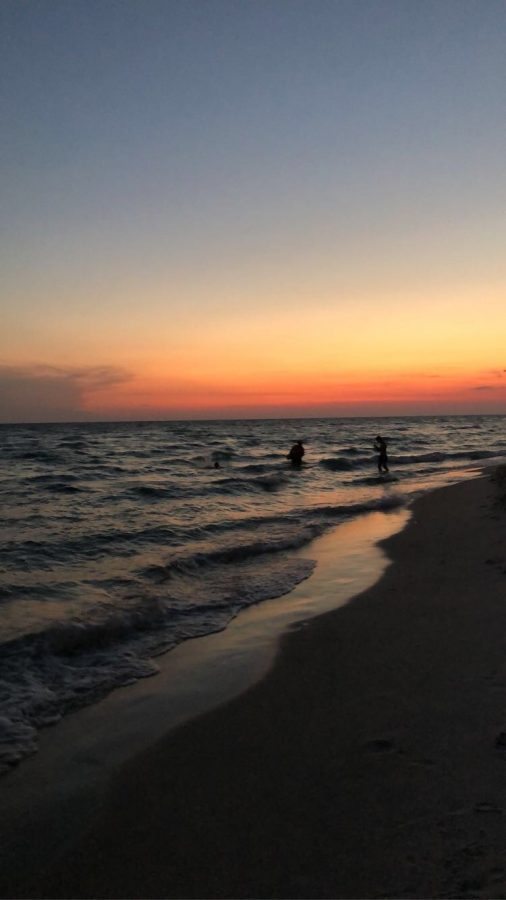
[0,508,410,897]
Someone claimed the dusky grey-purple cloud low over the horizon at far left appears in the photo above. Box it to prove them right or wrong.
[0,364,132,422]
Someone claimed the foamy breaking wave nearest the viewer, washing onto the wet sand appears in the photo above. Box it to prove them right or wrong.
[0,559,314,771]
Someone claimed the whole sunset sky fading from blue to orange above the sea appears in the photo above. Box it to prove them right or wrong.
[0,0,506,422]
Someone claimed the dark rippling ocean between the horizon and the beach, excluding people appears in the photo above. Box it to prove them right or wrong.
[0,416,506,771]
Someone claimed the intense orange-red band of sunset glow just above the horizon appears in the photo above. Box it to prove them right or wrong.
[83,370,506,418]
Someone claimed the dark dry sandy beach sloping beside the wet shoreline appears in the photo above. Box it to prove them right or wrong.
[1,474,506,898]
